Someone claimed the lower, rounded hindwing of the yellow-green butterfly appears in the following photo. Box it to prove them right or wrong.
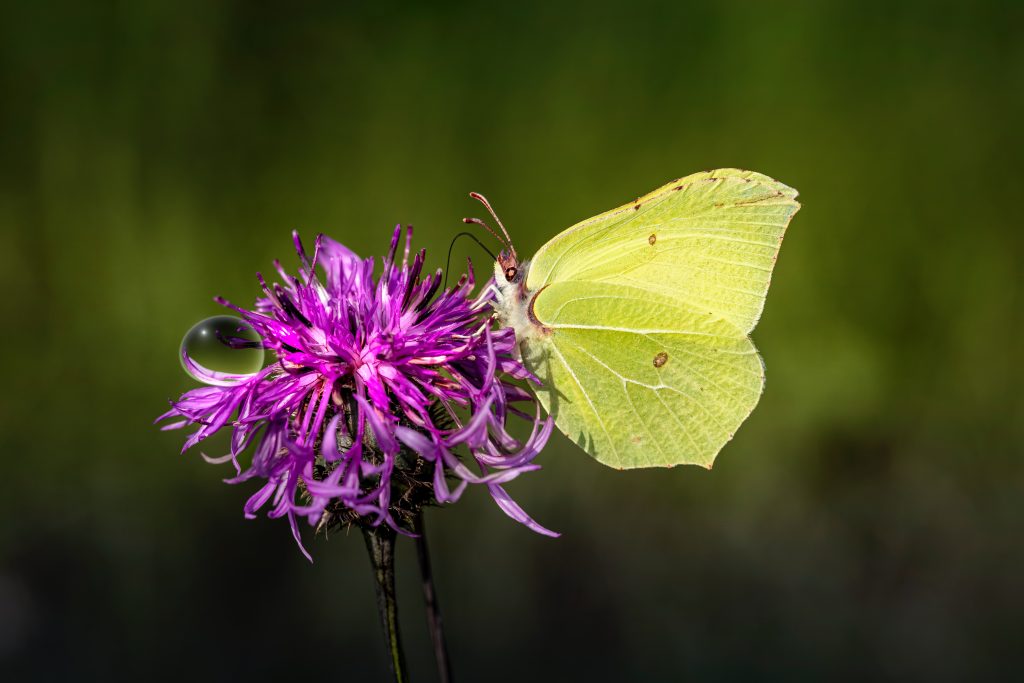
[524,283,764,468]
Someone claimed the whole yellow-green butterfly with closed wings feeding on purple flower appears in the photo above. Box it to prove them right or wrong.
[465,169,800,469]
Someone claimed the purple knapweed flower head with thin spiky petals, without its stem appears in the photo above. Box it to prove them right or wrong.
[158,226,554,557]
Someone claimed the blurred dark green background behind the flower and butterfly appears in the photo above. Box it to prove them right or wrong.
[0,0,1024,681]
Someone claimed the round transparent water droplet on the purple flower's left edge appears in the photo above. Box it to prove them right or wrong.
[180,315,263,386]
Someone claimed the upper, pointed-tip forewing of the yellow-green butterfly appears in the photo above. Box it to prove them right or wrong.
[527,169,800,333]
